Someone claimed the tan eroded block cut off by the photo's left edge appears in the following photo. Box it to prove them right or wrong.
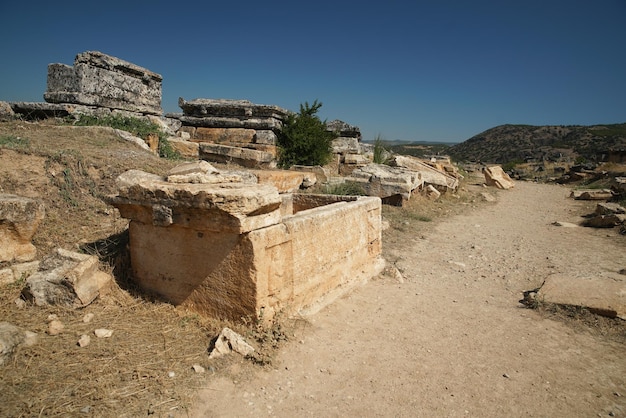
[0,194,45,262]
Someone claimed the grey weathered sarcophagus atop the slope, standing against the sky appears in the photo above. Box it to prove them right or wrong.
[44,51,163,115]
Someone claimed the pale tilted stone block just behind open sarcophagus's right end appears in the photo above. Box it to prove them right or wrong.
[346,163,424,200]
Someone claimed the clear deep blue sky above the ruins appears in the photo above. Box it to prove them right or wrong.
[0,0,626,142]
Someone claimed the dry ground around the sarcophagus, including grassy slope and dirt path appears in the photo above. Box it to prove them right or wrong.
[0,121,626,417]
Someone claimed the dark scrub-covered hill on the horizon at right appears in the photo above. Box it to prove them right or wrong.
[448,123,626,164]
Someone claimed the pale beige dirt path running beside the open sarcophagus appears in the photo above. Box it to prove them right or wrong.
[192,183,626,417]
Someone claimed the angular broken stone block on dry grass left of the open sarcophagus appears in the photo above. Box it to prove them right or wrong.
[22,248,112,307]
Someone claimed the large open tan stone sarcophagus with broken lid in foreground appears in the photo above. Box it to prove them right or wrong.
[109,162,384,320]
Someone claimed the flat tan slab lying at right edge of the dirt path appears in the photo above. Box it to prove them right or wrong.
[537,272,626,319]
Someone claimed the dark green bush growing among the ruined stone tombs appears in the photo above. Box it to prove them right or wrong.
[278,100,337,168]
